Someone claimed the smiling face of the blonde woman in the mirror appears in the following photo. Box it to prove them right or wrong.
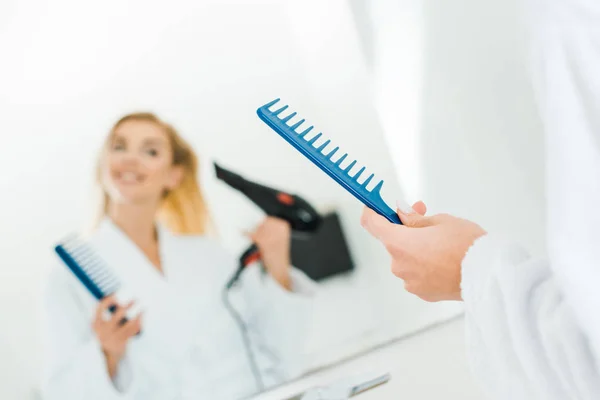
[101,119,182,204]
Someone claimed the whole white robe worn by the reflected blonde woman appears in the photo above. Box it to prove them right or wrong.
[42,218,315,400]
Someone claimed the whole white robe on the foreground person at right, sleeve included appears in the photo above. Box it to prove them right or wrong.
[462,0,600,400]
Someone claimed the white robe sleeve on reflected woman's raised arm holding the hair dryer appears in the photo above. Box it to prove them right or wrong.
[241,263,317,386]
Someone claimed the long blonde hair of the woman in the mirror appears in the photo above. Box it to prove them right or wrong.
[96,112,210,234]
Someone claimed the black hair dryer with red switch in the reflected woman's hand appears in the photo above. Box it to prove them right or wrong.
[214,163,322,288]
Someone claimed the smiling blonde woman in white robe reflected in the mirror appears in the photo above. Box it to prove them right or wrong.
[43,113,313,400]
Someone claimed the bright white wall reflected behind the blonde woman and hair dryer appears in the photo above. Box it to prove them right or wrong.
[0,0,456,399]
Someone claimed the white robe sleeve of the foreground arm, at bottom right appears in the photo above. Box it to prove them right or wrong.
[462,235,600,400]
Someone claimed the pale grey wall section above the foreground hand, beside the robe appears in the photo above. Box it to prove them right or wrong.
[421,0,545,254]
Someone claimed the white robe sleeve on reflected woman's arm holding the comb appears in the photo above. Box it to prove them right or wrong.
[42,269,179,400]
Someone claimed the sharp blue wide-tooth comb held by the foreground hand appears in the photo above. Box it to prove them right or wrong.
[256,99,402,224]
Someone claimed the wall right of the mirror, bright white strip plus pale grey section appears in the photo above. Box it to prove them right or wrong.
[364,0,545,254]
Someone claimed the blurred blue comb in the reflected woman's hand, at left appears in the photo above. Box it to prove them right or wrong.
[54,235,121,312]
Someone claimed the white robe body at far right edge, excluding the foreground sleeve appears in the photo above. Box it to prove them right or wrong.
[529,0,600,352]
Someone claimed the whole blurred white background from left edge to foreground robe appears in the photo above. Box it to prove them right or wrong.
[0,0,544,399]
